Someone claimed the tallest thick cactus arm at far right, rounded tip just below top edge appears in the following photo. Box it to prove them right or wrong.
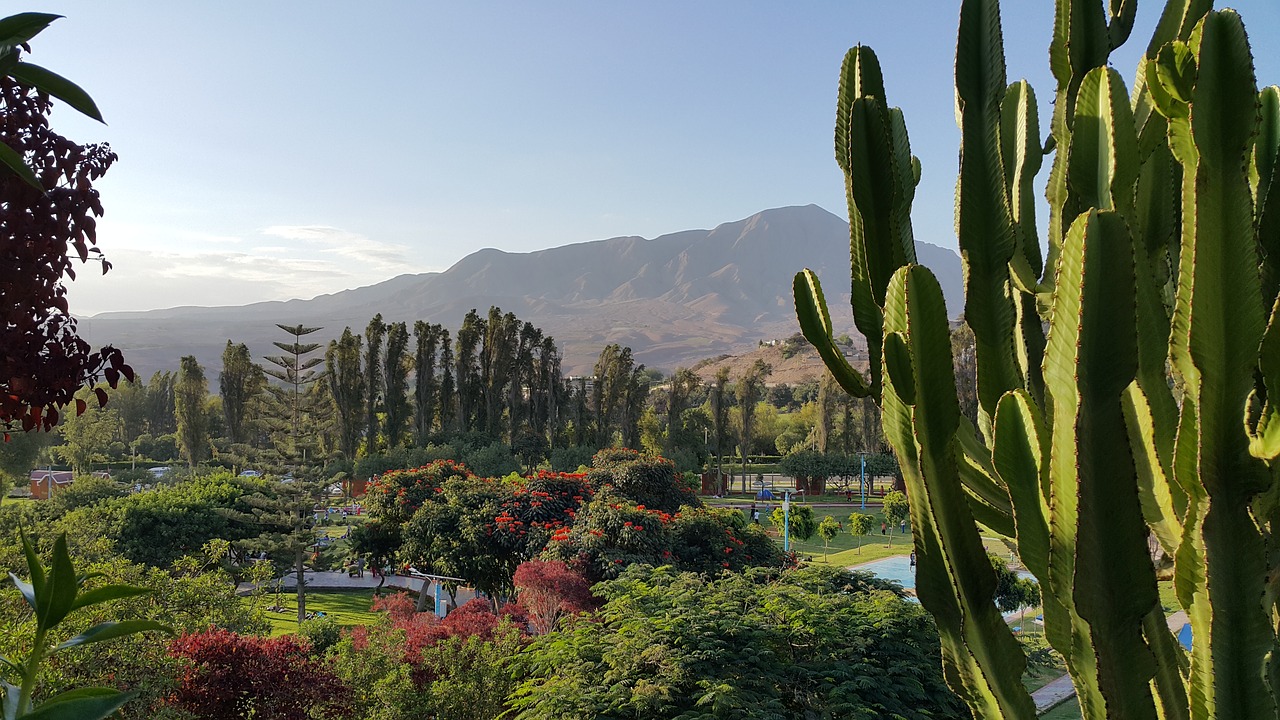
[1157,10,1276,717]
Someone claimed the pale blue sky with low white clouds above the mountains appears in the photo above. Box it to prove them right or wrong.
[24,0,1280,315]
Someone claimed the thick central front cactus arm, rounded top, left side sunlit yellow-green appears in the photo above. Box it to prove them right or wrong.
[1044,210,1158,717]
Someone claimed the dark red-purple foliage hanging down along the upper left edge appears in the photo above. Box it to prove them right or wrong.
[0,78,133,430]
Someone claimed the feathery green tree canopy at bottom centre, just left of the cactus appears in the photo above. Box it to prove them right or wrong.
[513,566,965,720]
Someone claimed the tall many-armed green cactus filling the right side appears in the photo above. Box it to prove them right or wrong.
[795,0,1280,719]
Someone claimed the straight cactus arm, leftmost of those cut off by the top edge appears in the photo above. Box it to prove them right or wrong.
[956,0,1023,422]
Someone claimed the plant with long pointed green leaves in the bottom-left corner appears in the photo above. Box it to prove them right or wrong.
[0,534,170,720]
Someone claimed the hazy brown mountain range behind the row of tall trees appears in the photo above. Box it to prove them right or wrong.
[79,205,964,376]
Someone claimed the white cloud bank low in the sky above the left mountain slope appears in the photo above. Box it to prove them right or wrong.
[68,225,440,315]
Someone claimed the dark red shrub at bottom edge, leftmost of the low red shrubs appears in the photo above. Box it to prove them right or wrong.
[169,629,349,720]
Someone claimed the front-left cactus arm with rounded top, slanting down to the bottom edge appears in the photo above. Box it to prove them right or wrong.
[883,265,1034,719]
